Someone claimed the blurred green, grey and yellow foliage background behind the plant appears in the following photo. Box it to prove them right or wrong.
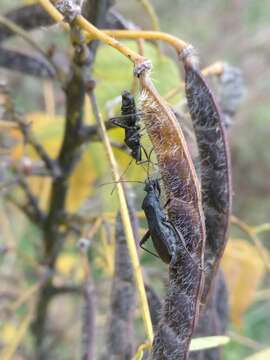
[0,0,270,360]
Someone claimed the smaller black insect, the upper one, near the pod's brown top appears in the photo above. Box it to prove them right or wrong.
[111,90,148,163]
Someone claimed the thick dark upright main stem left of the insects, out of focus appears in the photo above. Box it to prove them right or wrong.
[33,2,113,360]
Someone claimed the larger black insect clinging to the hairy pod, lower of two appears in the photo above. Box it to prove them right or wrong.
[140,179,193,264]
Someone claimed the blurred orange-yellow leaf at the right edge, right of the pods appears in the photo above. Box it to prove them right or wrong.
[222,239,265,326]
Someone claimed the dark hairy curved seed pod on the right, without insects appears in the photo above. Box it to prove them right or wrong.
[184,57,231,303]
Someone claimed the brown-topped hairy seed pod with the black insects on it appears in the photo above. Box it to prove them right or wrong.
[139,71,205,360]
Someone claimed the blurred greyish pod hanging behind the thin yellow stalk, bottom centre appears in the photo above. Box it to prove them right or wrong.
[102,184,140,360]
